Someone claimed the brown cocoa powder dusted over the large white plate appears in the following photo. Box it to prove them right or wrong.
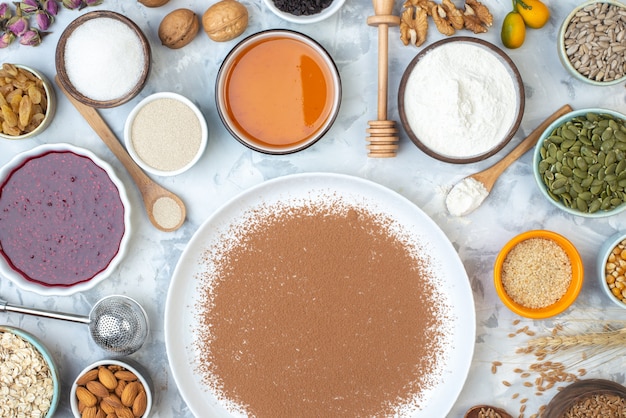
[194,197,450,417]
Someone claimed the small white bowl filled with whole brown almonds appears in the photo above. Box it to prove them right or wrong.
[70,359,152,418]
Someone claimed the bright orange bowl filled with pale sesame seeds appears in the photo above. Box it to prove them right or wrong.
[493,230,584,319]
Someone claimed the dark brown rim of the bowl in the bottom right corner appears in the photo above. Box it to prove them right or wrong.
[542,379,626,418]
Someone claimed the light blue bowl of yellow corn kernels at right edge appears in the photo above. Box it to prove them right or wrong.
[596,232,626,309]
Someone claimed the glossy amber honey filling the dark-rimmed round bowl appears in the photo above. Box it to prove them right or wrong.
[222,34,338,150]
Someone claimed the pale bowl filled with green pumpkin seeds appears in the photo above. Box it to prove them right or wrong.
[533,108,626,218]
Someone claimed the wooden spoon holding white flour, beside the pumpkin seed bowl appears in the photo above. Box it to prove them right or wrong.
[446,105,572,216]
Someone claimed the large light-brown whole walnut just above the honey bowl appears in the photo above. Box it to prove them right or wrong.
[202,0,248,42]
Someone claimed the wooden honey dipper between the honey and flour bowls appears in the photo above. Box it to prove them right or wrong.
[367,0,400,158]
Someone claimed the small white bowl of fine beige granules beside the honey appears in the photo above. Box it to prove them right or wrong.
[124,92,209,176]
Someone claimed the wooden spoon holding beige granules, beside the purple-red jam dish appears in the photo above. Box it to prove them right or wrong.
[55,77,187,232]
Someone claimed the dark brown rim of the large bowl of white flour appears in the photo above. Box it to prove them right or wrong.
[398,36,525,164]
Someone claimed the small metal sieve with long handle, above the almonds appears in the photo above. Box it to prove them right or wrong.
[0,295,148,355]
